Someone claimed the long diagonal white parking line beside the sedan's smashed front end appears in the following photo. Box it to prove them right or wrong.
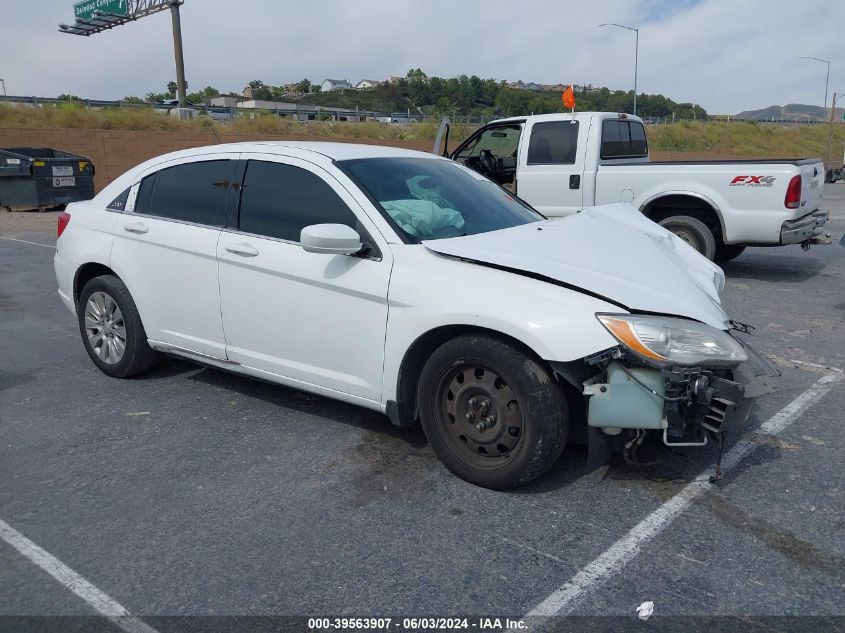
[525,374,842,617]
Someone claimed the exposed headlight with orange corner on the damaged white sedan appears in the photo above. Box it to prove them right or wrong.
[596,314,748,366]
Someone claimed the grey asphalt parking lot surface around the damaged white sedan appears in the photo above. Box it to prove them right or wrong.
[0,184,845,631]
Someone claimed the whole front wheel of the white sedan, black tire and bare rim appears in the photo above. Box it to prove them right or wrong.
[417,336,569,490]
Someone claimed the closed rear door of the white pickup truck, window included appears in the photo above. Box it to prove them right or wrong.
[517,119,587,217]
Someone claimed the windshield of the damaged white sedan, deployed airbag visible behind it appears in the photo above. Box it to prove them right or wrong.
[337,158,544,242]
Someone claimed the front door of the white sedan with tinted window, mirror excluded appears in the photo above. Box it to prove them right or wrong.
[217,154,392,401]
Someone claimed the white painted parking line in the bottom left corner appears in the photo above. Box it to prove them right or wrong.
[0,519,158,633]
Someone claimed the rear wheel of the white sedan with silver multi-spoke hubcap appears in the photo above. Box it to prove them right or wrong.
[76,275,157,378]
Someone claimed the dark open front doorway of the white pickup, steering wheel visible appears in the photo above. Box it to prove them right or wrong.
[452,125,522,186]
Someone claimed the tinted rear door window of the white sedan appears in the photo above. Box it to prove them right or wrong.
[135,160,235,226]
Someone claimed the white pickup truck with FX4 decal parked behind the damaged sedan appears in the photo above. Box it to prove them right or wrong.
[434,112,830,262]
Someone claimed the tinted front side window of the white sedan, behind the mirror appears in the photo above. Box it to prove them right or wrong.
[238,160,358,242]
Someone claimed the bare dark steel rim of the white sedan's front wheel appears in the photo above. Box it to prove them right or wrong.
[436,361,523,470]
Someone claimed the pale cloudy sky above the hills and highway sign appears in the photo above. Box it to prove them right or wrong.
[0,0,845,114]
